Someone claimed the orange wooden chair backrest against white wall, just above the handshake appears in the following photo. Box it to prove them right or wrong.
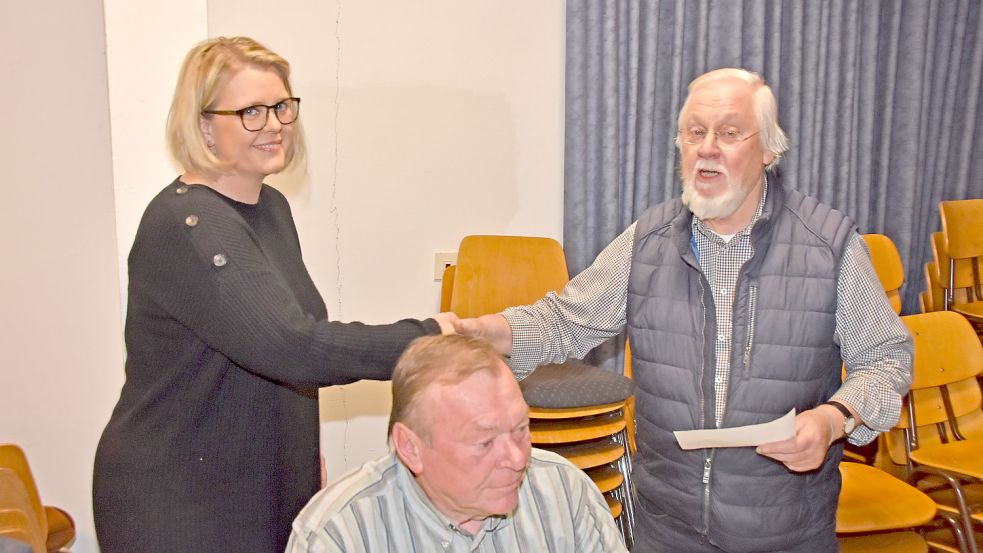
[450,235,569,317]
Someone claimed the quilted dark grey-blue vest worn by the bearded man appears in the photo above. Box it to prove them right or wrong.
[628,179,855,551]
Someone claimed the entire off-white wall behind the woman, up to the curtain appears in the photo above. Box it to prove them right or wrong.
[0,0,564,553]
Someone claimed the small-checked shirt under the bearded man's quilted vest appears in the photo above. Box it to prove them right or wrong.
[503,183,913,445]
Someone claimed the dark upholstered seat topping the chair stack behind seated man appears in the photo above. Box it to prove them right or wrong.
[519,359,631,409]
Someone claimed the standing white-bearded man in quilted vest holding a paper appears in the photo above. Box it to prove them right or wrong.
[457,68,913,553]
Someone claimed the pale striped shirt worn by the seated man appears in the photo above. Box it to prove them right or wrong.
[286,448,627,553]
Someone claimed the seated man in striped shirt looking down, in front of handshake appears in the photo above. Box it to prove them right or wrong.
[287,336,626,553]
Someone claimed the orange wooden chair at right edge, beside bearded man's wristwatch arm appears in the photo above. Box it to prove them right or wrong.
[886,311,983,553]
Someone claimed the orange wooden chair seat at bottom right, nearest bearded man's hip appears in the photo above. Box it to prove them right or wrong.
[836,462,935,534]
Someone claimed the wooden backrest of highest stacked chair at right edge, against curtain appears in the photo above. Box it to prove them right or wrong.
[939,199,983,300]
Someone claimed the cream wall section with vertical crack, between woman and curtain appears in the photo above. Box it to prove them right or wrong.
[202,0,564,477]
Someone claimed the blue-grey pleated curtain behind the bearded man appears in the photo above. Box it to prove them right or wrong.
[564,0,983,368]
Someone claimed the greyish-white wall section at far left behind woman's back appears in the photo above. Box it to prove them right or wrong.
[0,4,123,552]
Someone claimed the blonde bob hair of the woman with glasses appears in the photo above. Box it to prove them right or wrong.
[166,36,306,177]
